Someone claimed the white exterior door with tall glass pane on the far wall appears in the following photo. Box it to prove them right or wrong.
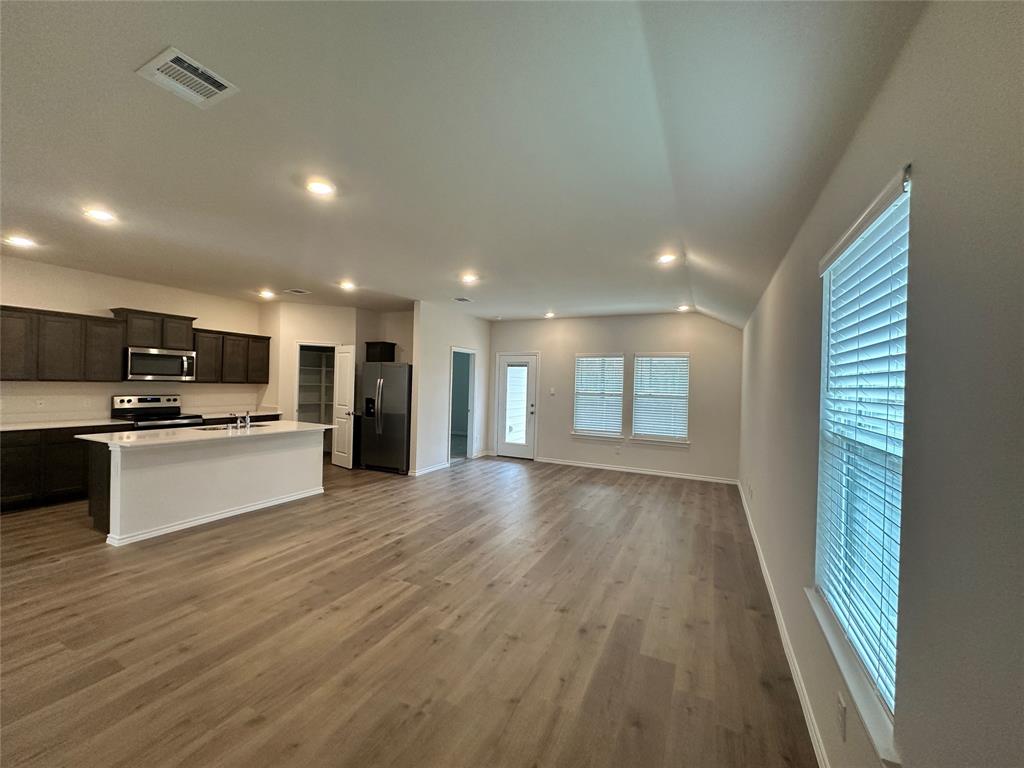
[498,354,537,459]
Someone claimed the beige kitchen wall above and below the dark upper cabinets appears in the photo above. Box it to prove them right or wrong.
[0,256,272,423]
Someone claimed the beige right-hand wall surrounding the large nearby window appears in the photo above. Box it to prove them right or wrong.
[740,3,1024,768]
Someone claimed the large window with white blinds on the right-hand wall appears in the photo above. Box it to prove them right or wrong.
[815,176,910,713]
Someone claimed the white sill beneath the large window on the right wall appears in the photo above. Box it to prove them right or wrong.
[804,587,902,768]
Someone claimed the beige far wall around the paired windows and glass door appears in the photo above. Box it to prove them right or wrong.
[488,312,741,479]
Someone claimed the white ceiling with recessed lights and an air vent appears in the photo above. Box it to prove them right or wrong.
[0,2,921,326]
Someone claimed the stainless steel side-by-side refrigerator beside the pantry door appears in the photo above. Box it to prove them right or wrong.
[359,362,413,474]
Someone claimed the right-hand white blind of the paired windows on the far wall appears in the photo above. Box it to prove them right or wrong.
[633,354,690,440]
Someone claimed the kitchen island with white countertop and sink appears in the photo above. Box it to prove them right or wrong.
[76,421,331,546]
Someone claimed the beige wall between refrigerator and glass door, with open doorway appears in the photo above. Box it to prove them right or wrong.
[410,301,490,473]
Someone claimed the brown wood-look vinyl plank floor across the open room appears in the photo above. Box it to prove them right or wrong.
[0,459,816,768]
